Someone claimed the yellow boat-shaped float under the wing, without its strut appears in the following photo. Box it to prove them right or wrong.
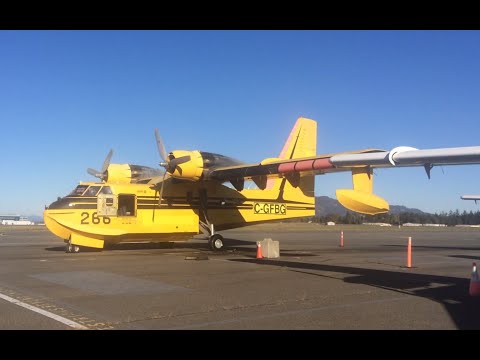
[336,189,390,215]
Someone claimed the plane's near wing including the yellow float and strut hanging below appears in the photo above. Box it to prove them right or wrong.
[207,146,480,215]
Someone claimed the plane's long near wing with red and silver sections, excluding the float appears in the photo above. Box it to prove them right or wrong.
[206,146,480,181]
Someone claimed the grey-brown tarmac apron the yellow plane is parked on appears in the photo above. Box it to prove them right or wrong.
[0,223,480,330]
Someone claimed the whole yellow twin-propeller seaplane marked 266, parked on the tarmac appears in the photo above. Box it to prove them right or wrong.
[44,118,480,252]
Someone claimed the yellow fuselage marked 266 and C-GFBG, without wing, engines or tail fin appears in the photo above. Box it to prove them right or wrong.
[44,179,315,248]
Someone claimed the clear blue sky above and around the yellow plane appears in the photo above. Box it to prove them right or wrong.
[0,31,480,215]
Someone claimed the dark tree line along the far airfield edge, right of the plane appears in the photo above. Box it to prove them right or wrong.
[301,210,480,226]
